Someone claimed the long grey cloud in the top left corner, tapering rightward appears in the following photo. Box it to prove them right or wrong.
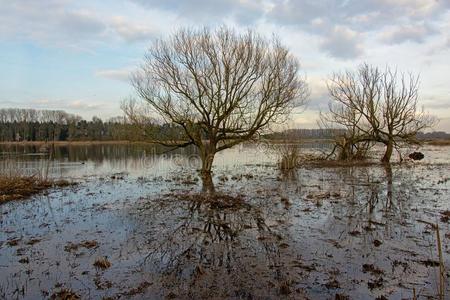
[0,0,155,48]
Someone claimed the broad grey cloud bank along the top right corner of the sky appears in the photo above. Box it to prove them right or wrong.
[266,0,450,58]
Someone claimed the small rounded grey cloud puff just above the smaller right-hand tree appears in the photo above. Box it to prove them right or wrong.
[321,26,364,59]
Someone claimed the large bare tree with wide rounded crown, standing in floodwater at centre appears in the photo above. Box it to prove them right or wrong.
[132,28,307,192]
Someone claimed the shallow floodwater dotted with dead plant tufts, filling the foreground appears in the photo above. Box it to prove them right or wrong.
[0,145,450,299]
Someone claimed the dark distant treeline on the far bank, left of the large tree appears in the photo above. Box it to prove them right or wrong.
[0,108,180,142]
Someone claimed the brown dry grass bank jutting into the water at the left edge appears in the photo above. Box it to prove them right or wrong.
[0,175,72,204]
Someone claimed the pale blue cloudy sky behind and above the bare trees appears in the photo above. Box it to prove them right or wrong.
[0,0,450,132]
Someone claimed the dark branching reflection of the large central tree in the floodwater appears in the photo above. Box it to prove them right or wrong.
[128,194,296,297]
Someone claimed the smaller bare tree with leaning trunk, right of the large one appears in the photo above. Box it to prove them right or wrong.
[328,64,434,162]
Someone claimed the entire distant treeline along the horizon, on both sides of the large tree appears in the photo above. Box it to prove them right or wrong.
[0,108,450,142]
